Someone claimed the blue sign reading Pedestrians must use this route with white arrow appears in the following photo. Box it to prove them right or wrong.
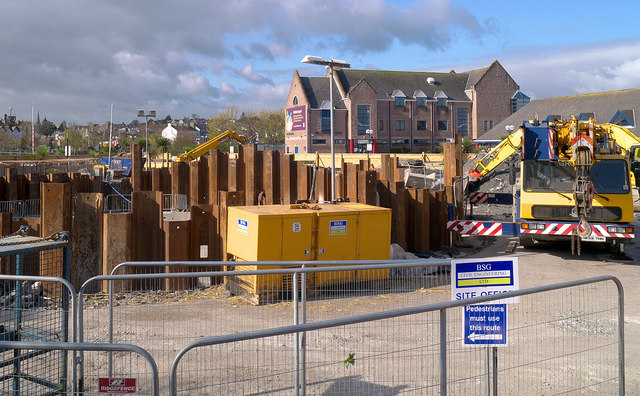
[463,304,507,346]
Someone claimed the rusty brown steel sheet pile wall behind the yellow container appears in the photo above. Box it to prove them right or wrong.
[0,140,462,287]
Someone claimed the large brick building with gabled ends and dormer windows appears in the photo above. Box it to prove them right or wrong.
[285,61,528,153]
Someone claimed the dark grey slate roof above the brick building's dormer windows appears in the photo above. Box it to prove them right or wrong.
[335,69,470,101]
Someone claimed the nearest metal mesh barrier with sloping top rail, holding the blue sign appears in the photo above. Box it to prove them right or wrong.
[169,276,625,396]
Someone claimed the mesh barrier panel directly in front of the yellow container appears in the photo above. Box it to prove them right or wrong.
[80,260,450,394]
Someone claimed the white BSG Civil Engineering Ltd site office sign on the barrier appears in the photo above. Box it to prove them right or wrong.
[451,257,520,304]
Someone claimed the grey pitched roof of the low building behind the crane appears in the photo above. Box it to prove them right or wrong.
[482,88,640,139]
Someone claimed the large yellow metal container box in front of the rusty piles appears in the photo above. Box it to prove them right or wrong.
[227,203,391,303]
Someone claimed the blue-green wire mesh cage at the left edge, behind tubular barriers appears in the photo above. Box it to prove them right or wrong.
[0,237,70,395]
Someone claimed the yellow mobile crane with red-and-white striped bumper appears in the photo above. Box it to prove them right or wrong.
[448,117,640,254]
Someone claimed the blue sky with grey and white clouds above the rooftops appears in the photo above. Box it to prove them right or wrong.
[0,0,640,124]
